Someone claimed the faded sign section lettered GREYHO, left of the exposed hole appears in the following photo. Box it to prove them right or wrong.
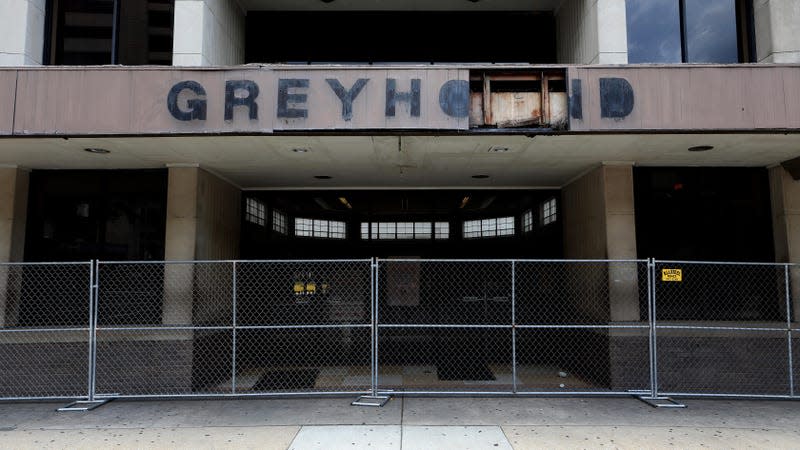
[9,68,469,135]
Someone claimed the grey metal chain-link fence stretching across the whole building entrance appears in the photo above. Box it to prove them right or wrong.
[0,258,800,402]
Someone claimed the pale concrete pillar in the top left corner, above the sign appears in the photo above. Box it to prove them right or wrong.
[0,0,45,66]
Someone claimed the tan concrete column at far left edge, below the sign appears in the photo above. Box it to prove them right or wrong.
[0,167,28,327]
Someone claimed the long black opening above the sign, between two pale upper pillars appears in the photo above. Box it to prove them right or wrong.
[245,11,556,64]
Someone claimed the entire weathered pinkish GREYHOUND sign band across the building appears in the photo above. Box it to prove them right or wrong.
[0,65,800,136]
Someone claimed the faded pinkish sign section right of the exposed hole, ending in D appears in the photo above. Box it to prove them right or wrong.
[568,65,800,131]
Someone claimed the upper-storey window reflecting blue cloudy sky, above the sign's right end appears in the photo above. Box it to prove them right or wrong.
[625,0,752,64]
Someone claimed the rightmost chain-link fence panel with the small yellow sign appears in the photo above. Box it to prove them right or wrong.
[654,261,792,396]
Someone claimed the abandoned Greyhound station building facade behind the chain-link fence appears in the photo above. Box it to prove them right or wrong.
[0,0,800,400]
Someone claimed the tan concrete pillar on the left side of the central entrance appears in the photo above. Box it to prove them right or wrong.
[162,166,241,324]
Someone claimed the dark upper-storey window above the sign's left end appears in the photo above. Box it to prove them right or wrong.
[45,0,175,65]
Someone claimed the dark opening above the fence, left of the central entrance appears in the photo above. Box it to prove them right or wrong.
[25,170,167,261]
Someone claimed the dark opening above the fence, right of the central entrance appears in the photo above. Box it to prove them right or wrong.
[634,167,775,262]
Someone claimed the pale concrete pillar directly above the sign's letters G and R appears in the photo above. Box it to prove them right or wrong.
[172,0,245,66]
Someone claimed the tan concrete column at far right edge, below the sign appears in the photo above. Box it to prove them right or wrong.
[769,166,800,320]
